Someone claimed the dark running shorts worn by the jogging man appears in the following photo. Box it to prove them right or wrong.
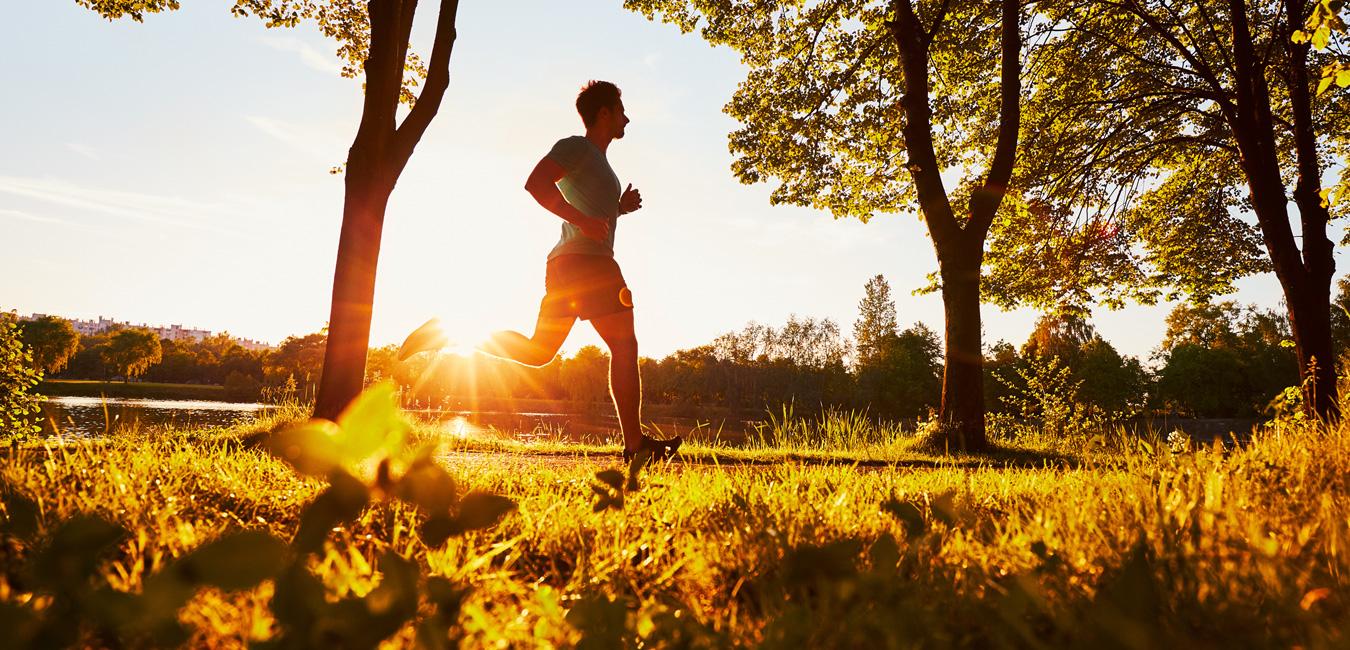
[539,254,633,320]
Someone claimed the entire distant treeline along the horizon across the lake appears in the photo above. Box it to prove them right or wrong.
[20,276,1350,419]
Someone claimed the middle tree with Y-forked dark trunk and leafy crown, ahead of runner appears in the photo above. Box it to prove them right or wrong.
[624,0,1022,450]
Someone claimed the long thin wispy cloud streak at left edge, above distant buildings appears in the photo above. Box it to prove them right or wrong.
[0,176,228,232]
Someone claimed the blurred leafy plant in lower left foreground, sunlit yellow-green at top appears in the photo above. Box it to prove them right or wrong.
[0,384,516,649]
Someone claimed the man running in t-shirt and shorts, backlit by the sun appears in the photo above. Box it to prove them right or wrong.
[398,81,683,461]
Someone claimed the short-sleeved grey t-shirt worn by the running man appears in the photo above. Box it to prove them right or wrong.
[548,135,622,259]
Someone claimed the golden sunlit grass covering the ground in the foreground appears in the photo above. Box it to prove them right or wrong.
[0,394,1350,649]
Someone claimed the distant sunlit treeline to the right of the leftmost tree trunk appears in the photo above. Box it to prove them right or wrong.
[367,276,1328,419]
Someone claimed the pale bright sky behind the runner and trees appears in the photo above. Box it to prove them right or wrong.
[0,0,1312,361]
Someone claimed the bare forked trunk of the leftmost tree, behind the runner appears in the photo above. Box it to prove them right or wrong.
[315,0,459,419]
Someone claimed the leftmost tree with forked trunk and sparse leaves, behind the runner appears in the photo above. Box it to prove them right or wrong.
[76,0,459,419]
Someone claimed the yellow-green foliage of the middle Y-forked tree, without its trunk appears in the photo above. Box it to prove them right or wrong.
[624,0,1015,222]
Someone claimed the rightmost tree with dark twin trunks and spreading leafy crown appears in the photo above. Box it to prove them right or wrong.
[1026,0,1350,416]
